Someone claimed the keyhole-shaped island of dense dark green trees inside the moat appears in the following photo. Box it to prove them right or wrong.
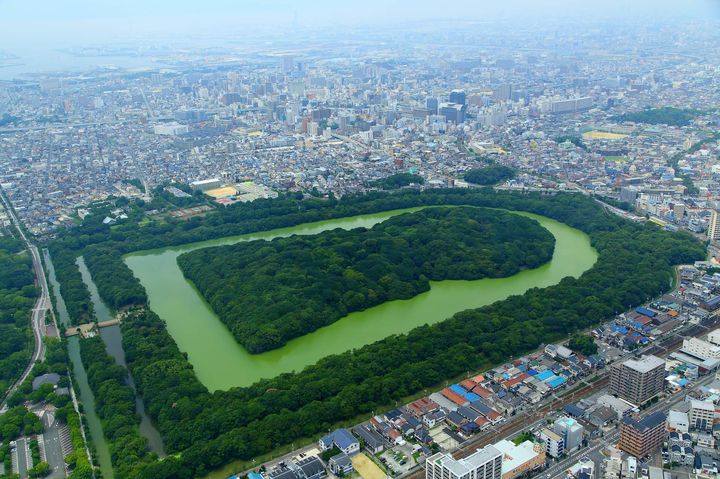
[178,207,554,353]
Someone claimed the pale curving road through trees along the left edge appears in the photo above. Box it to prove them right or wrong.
[0,189,51,413]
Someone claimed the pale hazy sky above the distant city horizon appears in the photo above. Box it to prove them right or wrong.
[0,0,720,51]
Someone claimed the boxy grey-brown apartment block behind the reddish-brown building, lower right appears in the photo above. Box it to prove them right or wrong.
[610,356,665,406]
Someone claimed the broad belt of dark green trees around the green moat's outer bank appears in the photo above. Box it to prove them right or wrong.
[47,188,704,478]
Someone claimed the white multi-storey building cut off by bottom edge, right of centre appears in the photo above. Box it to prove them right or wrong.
[425,446,503,479]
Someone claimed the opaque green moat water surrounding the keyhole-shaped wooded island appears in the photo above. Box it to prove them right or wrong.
[125,208,597,391]
